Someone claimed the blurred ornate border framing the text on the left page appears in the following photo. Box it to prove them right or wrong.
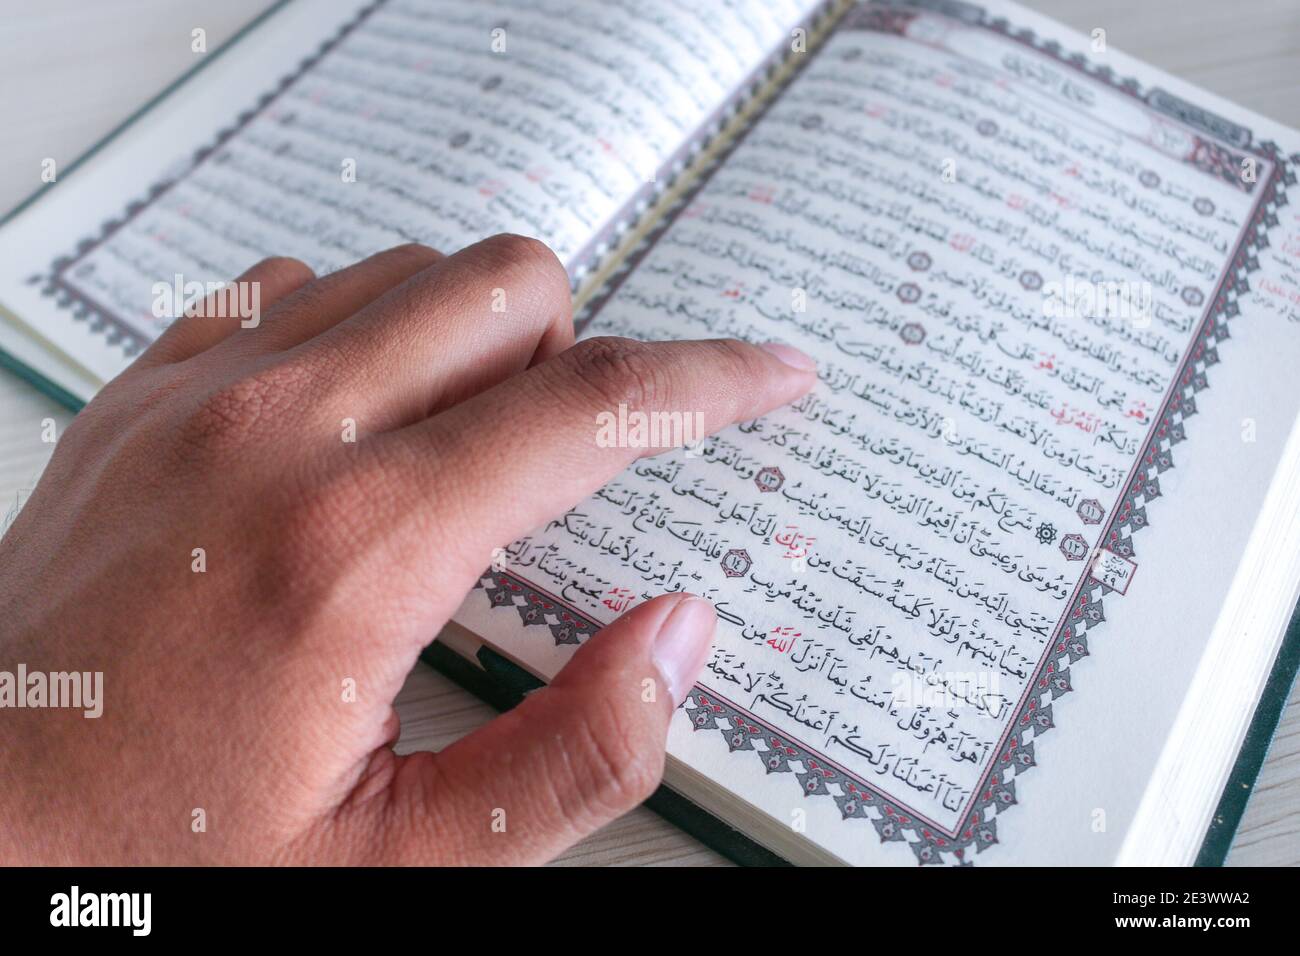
[27,0,845,358]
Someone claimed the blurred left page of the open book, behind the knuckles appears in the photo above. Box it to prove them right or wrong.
[0,0,824,390]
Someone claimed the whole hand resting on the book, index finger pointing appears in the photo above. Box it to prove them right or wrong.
[0,235,815,865]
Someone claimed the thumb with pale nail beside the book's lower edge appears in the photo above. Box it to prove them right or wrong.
[361,594,715,865]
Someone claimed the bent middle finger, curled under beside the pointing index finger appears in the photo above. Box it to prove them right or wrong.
[303,235,573,432]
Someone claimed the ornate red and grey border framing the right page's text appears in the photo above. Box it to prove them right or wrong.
[477,0,1300,865]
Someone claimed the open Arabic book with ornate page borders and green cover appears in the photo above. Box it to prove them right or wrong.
[0,0,1300,865]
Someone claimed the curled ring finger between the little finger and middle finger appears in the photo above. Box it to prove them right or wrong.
[242,242,443,351]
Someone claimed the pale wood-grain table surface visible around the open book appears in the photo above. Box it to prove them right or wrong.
[0,0,1300,866]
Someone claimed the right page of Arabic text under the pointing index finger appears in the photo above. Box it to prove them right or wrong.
[458,3,1300,865]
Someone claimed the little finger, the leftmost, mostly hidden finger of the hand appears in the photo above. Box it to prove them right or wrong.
[137,256,316,365]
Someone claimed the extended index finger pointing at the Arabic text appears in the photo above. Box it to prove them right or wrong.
[373,338,816,575]
